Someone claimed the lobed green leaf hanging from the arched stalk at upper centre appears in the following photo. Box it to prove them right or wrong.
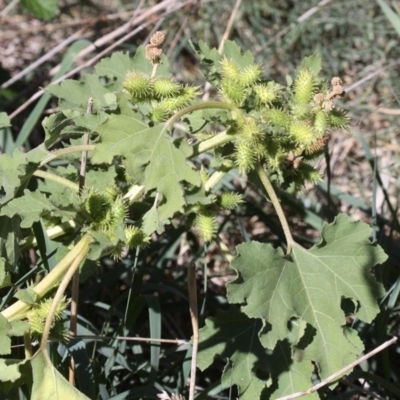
[92,112,200,220]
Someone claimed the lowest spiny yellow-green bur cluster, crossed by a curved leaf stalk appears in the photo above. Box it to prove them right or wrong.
[26,297,69,339]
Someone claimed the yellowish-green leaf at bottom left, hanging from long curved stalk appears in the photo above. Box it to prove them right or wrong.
[31,351,89,400]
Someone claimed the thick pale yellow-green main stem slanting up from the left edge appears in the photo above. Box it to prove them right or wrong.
[1,234,92,322]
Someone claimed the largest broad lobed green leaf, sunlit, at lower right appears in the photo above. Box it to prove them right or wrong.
[228,215,386,377]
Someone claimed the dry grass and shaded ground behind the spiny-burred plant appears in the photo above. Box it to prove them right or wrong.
[0,0,400,399]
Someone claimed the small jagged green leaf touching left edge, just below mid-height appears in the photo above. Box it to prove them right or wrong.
[0,190,54,228]
